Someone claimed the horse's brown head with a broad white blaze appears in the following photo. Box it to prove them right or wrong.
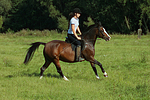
[97,23,111,41]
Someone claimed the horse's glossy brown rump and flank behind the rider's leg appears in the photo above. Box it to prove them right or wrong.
[44,40,75,62]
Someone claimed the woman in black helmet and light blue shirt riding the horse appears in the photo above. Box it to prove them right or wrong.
[67,8,84,61]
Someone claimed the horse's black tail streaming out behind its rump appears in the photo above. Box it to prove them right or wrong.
[24,42,46,64]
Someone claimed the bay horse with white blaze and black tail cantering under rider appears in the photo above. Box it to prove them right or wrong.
[24,23,111,81]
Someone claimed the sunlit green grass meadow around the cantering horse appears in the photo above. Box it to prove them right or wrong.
[0,31,150,100]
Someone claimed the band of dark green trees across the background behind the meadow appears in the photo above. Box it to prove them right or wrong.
[0,0,150,34]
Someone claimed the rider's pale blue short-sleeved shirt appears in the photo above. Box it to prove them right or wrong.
[68,17,79,34]
